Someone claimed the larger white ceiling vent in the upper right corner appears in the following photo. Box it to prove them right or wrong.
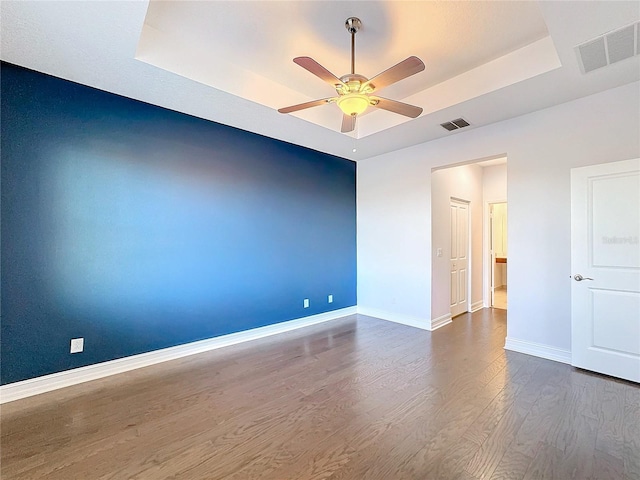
[576,22,640,73]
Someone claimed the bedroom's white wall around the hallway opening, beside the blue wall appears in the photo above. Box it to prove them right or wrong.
[357,82,640,352]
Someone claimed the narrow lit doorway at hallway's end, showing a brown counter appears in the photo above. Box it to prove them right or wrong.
[489,202,508,310]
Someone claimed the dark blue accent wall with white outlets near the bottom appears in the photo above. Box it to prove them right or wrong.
[1,63,356,384]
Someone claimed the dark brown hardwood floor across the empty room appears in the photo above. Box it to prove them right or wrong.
[1,309,640,480]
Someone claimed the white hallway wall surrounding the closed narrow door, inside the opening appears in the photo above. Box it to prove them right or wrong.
[431,165,483,319]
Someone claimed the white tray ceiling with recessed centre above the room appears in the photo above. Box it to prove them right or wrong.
[0,0,640,160]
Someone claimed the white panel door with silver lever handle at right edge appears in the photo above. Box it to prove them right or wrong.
[571,159,640,382]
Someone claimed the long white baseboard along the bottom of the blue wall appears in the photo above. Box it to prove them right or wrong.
[0,306,357,404]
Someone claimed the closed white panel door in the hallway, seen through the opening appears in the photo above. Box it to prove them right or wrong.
[450,198,469,317]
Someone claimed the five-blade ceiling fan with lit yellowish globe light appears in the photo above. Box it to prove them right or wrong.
[278,17,424,133]
